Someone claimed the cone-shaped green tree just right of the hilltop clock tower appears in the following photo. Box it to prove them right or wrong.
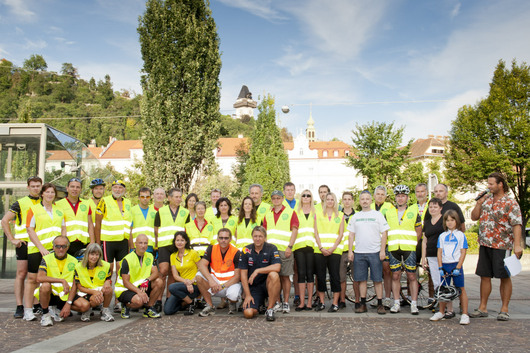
[242,94,290,200]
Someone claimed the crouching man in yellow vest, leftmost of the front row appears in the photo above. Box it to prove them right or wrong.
[37,235,90,326]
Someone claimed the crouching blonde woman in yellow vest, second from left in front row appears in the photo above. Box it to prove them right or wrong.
[75,243,114,322]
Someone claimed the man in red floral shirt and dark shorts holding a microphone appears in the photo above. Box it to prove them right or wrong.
[469,173,523,321]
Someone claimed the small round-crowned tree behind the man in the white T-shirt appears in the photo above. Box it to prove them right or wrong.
[346,121,413,189]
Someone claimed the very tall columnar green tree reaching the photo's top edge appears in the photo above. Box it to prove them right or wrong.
[138,0,221,190]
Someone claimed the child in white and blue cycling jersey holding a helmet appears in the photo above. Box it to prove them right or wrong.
[430,210,469,325]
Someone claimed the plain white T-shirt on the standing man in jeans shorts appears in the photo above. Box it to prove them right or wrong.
[348,210,390,254]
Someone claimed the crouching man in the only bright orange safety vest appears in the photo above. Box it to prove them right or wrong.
[197,228,241,317]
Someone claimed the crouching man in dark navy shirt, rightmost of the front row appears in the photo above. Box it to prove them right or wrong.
[239,226,281,321]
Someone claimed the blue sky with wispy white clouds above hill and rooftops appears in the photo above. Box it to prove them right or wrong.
[0,0,530,143]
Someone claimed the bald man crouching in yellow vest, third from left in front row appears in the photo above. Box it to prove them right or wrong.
[114,234,164,319]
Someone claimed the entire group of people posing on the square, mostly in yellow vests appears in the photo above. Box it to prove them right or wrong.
[2,173,522,326]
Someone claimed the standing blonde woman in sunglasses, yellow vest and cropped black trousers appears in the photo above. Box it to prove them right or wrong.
[293,189,315,311]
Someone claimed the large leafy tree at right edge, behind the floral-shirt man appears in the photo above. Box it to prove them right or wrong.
[446,60,530,224]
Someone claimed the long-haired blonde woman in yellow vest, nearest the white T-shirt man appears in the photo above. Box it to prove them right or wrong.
[315,193,344,312]
